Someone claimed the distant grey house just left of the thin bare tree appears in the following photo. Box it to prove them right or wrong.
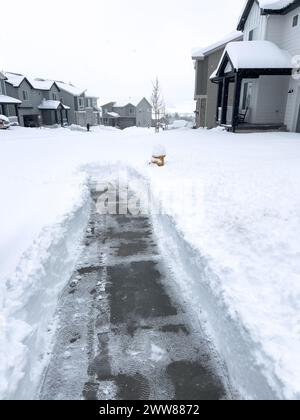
[102,98,152,130]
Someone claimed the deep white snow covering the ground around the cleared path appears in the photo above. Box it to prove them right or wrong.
[0,127,300,399]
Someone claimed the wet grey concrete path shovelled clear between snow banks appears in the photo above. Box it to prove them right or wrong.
[40,186,228,400]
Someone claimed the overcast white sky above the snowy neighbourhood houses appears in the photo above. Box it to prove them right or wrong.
[0,0,244,111]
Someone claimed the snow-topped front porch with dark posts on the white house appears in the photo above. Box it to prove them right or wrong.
[211,41,293,132]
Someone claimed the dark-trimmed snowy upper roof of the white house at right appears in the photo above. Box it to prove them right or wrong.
[237,0,300,31]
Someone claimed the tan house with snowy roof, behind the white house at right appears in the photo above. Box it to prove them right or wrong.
[192,32,243,128]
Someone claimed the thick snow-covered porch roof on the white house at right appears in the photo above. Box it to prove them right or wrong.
[217,41,293,71]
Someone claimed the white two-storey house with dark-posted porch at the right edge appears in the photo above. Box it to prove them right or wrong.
[212,0,300,132]
